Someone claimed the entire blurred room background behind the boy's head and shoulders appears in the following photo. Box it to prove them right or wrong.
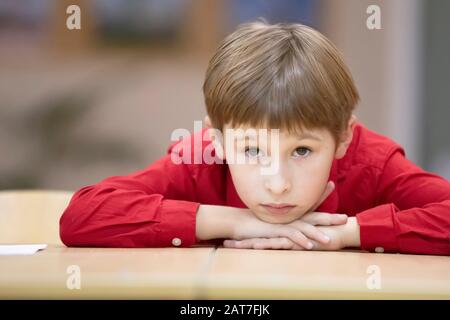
[0,0,450,190]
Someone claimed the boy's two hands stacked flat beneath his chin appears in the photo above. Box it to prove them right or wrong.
[229,181,347,249]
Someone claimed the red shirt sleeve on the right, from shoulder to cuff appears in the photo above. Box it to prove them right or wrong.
[356,147,450,255]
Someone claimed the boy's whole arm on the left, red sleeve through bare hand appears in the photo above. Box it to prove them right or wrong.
[60,152,341,247]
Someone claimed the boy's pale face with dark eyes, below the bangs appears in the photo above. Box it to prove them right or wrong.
[211,119,353,223]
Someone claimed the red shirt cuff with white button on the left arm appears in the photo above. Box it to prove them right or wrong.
[158,199,200,247]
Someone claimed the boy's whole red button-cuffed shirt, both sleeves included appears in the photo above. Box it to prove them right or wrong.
[60,123,450,255]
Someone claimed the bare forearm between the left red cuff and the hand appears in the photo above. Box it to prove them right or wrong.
[195,205,248,240]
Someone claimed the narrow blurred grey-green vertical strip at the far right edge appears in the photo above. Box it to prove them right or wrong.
[421,0,450,180]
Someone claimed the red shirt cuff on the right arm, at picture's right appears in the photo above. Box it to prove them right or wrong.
[356,204,399,252]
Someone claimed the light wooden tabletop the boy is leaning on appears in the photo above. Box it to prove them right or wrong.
[0,245,450,299]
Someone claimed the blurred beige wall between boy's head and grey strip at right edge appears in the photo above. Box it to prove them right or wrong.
[322,0,423,165]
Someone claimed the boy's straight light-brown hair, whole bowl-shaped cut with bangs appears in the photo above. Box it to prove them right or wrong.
[203,22,359,139]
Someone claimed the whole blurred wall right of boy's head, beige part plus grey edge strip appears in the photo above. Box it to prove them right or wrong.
[320,0,450,179]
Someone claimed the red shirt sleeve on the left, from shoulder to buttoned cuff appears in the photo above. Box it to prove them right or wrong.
[60,153,200,247]
